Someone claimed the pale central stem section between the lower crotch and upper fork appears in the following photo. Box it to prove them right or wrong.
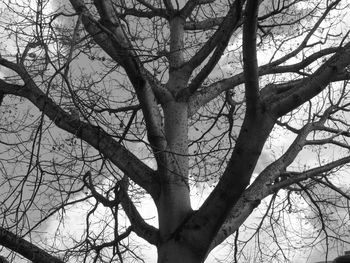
[157,101,191,240]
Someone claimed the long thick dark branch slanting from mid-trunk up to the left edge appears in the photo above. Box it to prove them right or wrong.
[0,78,158,198]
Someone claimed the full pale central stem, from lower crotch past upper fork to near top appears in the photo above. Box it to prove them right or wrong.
[156,16,192,243]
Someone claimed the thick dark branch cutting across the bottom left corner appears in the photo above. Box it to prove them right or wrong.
[0,227,64,263]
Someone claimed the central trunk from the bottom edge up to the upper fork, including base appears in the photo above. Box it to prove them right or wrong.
[157,101,201,263]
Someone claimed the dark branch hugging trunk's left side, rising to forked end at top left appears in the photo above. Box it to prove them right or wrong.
[71,0,167,163]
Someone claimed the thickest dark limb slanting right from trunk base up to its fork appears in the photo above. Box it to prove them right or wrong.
[183,113,275,258]
